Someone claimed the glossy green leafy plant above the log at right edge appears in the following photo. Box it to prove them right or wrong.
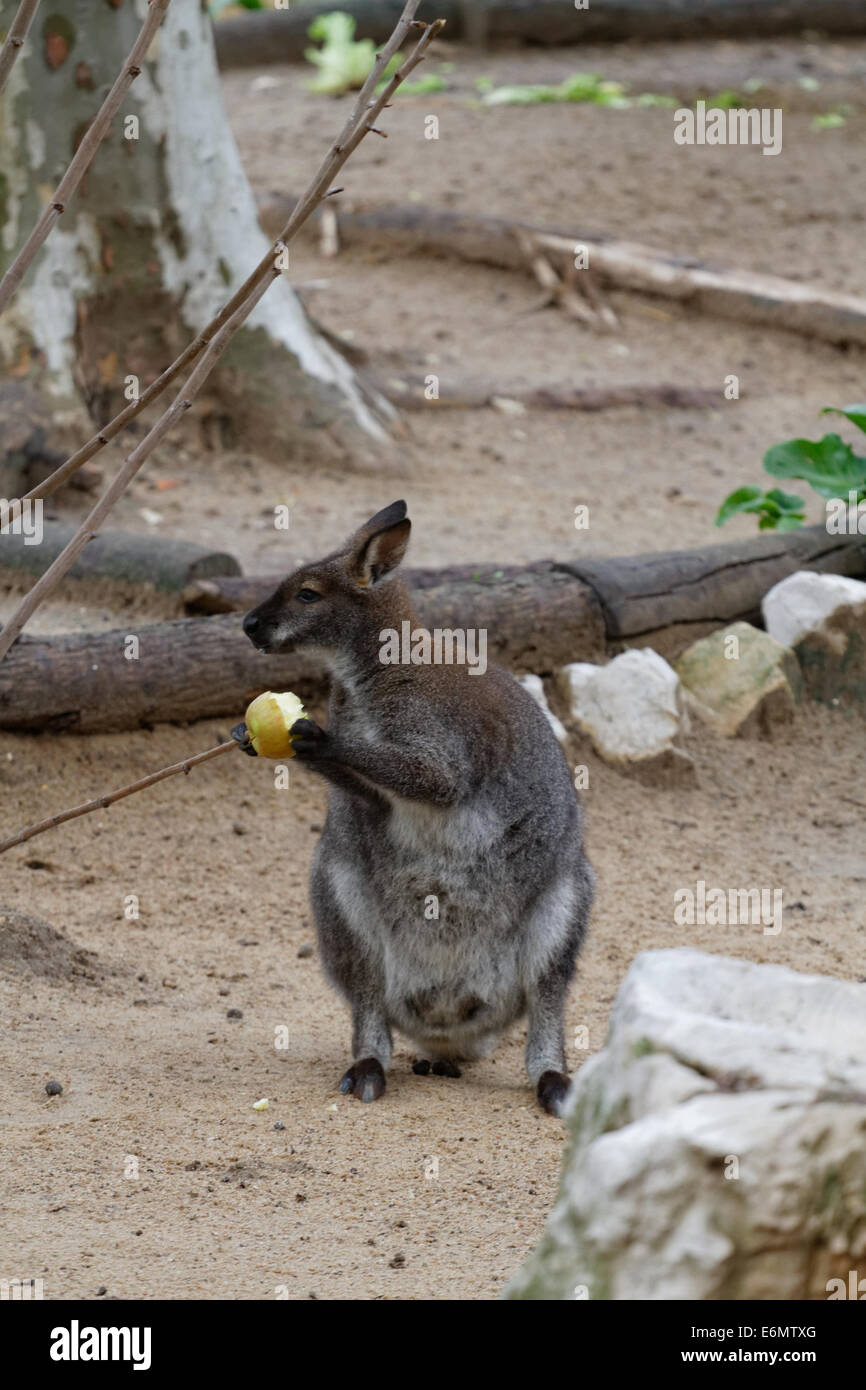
[716,404,866,531]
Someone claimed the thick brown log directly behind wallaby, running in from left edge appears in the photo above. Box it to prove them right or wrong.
[0,562,605,734]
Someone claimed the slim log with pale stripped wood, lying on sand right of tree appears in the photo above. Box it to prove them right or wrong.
[259,193,866,353]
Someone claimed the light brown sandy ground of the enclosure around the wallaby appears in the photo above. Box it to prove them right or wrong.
[0,35,866,1300]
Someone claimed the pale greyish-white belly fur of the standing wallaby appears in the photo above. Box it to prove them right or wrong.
[322,794,574,1058]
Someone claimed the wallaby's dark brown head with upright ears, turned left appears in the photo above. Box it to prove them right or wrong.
[243,502,411,655]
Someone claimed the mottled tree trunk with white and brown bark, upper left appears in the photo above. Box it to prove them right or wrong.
[0,0,393,459]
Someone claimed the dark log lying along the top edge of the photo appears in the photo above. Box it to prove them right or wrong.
[214,0,866,68]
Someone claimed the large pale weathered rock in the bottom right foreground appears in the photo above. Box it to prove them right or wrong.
[506,948,866,1300]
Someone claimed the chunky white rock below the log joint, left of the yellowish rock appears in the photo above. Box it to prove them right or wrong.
[557,646,694,774]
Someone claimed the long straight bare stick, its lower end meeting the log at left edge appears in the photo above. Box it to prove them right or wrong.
[0,12,445,660]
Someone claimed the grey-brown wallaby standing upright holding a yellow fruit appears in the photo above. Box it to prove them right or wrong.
[243,502,595,1115]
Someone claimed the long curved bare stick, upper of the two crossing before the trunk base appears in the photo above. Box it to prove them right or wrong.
[19,0,445,500]
